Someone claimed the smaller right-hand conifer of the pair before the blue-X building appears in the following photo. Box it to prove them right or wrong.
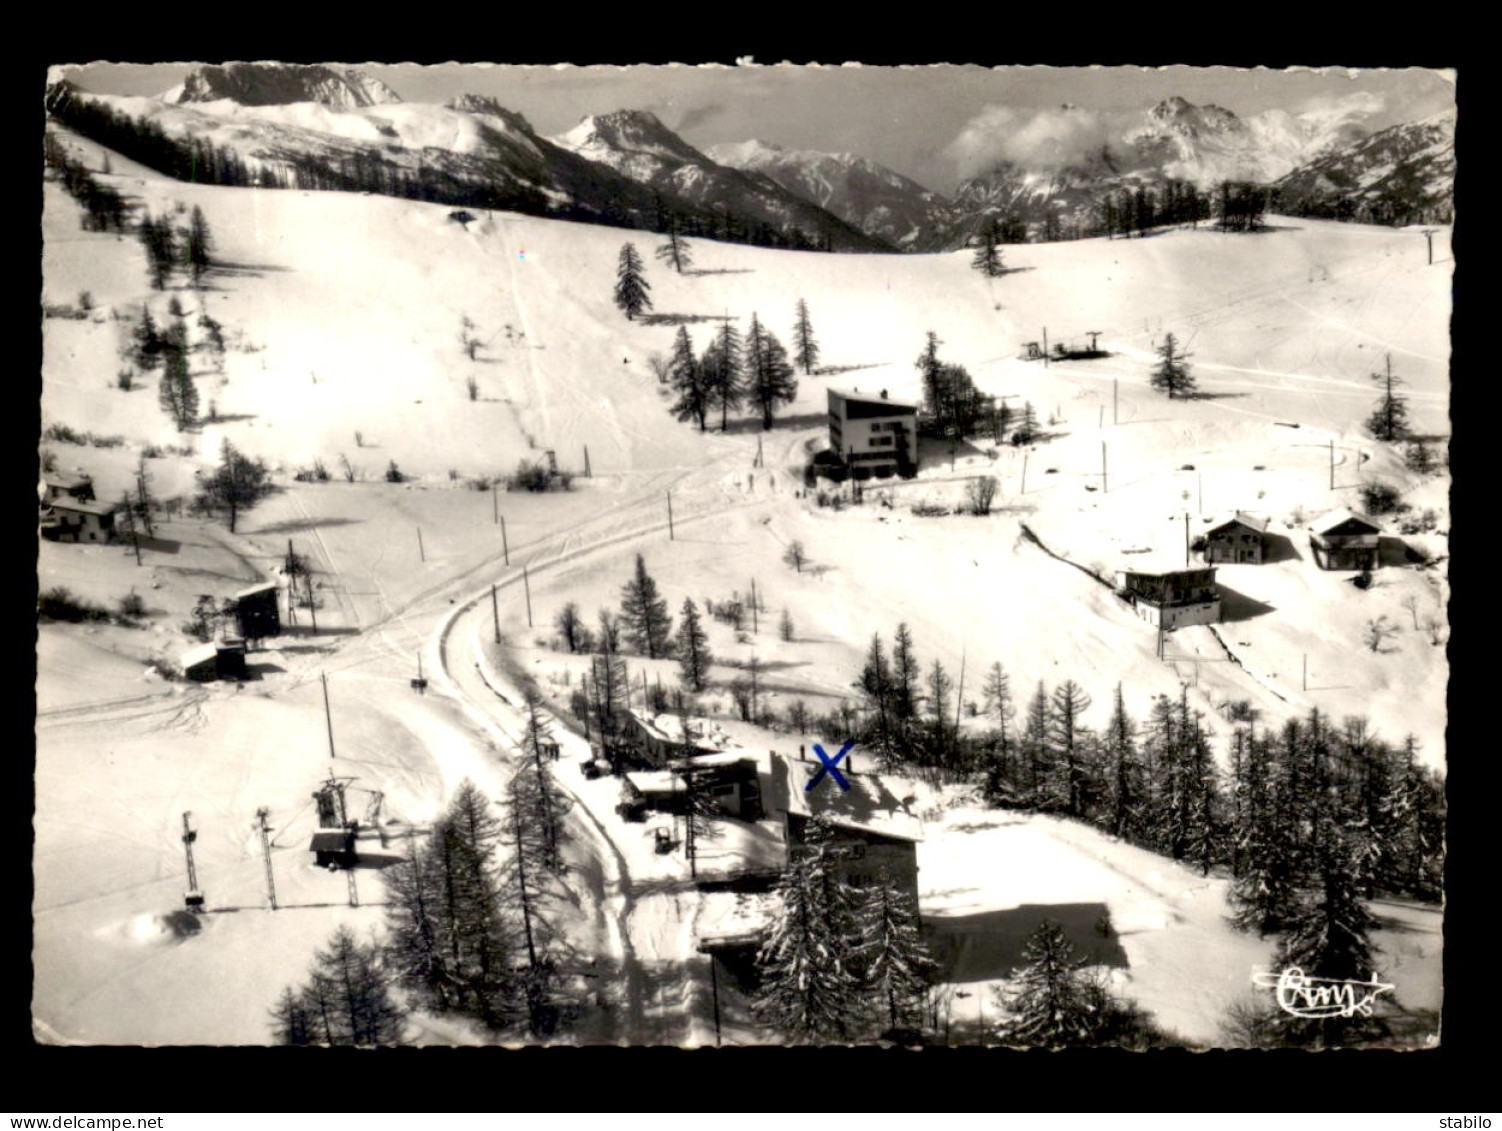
[852,876,937,1029]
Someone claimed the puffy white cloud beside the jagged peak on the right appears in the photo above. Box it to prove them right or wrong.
[943,105,1125,179]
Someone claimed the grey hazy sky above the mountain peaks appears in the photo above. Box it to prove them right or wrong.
[55,63,1455,194]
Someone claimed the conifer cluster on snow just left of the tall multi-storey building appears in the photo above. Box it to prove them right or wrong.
[667,302,819,431]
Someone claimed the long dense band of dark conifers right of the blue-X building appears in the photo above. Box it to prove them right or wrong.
[829,625,1445,1041]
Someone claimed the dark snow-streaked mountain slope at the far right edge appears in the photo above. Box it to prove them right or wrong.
[1274,114,1455,224]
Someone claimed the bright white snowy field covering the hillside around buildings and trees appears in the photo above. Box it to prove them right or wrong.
[33,121,1451,1044]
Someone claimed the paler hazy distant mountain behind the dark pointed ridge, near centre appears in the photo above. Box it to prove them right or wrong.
[706,140,954,251]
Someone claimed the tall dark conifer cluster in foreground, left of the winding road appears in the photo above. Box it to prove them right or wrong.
[382,698,569,1036]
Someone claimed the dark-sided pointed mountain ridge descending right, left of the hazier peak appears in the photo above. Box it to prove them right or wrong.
[554,110,889,251]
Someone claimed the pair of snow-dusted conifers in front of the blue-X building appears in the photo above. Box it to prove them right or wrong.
[756,817,934,1042]
